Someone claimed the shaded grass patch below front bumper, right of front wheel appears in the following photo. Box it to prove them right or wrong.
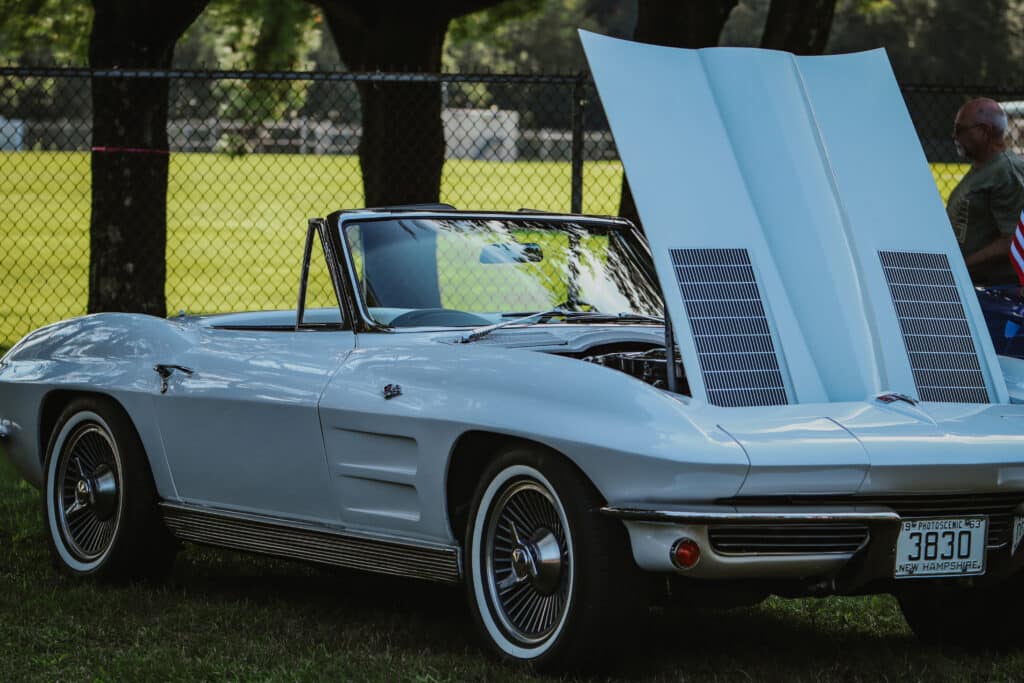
[617,596,1022,681]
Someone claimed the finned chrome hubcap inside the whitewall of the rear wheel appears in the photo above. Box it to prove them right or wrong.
[53,424,121,561]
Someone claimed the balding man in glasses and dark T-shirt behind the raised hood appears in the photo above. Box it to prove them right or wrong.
[946,97,1024,285]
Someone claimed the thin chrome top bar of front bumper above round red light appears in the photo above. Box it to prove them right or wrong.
[601,506,900,524]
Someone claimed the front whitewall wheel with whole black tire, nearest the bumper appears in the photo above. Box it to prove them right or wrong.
[465,449,639,671]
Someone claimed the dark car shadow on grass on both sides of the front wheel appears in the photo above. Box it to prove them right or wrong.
[155,548,1024,681]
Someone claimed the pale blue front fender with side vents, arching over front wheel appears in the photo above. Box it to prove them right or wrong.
[321,344,749,538]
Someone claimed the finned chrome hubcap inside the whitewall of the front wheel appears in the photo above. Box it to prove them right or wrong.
[484,480,571,645]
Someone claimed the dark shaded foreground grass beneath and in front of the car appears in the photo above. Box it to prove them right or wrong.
[0,452,1024,682]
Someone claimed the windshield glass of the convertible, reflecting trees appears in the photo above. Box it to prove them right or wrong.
[343,217,663,327]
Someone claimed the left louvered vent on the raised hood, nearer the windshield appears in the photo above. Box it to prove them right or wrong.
[669,249,788,407]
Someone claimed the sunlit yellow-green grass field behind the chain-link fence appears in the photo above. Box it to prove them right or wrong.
[0,152,965,345]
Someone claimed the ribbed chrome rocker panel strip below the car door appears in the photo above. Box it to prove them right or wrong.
[160,503,462,584]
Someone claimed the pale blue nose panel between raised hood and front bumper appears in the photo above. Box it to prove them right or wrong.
[712,401,1024,497]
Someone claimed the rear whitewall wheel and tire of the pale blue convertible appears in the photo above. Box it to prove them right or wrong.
[43,396,175,581]
